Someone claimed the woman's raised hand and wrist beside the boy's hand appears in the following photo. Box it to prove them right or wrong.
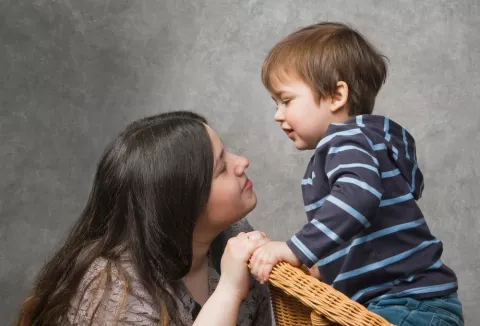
[219,231,270,301]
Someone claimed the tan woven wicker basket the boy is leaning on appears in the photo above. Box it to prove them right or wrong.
[269,262,393,326]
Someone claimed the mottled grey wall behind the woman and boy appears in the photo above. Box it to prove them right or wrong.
[0,0,480,325]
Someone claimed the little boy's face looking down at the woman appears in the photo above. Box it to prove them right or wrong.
[272,79,338,150]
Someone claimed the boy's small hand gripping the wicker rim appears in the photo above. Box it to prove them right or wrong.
[250,241,301,284]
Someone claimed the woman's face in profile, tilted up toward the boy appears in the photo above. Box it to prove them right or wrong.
[197,126,257,236]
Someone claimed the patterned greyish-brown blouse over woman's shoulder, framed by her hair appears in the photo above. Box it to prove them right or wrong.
[67,256,159,326]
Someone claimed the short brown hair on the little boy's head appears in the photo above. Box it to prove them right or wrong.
[262,22,387,116]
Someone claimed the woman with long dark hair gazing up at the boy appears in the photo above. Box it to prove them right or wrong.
[17,111,271,326]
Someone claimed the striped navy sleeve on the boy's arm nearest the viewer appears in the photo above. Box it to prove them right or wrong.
[287,129,385,267]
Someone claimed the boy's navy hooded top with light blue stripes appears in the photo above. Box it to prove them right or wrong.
[287,115,457,304]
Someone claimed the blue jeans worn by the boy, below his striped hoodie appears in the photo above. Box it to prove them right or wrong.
[367,294,463,326]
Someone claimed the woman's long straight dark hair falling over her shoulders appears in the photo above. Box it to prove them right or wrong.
[17,111,213,326]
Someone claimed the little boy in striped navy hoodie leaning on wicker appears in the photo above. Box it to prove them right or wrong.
[251,23,463,325]
